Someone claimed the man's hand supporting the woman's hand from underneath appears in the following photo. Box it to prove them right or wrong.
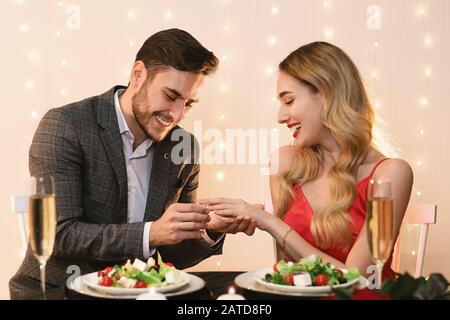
[207,212,256,236]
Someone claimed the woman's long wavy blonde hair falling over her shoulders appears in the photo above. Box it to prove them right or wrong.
[272,42,374,249]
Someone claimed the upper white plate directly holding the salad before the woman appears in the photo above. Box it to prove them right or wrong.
[253,268,360,294]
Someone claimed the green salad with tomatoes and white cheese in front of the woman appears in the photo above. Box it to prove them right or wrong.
[263,255,360,287]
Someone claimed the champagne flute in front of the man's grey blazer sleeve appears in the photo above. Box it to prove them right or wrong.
[29,176,56,299]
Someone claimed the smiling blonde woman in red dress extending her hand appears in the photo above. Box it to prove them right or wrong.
[202,42,413,278]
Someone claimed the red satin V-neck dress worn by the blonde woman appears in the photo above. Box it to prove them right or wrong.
[283,159,396,279]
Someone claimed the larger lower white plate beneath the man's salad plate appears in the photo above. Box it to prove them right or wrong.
[67,273,206,299]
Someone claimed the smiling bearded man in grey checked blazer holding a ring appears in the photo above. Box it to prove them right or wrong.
[10,29,255,299]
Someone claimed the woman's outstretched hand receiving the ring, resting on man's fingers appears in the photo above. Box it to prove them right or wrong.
[199,198,273,230]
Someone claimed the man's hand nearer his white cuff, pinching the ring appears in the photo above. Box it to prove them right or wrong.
[149,203,210,247]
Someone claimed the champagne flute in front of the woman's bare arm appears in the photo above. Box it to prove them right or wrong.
[366,180,394,289]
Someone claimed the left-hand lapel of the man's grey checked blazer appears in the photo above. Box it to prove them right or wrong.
[97,86,128,223]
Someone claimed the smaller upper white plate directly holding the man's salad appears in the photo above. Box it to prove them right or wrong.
[83,271,190,296]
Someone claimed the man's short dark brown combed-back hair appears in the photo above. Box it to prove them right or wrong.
[136,29,219,75]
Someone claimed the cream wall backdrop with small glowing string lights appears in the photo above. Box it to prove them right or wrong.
[0,0,450,298]
